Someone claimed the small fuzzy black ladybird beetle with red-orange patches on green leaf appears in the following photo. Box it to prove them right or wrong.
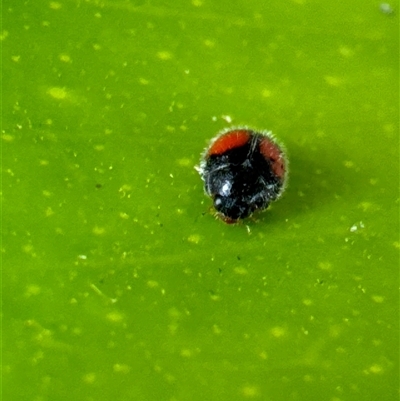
[196,127,288,224]
